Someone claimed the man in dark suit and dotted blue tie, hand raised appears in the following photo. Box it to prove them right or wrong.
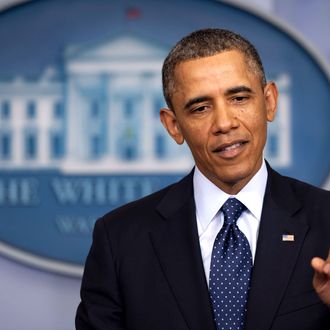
[76,29,330,330]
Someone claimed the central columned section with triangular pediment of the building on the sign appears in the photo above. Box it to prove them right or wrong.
[62,35,190,173]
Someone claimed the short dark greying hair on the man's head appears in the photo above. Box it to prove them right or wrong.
[162,29,266,110]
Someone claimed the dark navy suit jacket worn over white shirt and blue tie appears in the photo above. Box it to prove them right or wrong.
[76,166,330,330]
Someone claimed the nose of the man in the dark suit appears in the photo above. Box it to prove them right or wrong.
[212,103,239,135]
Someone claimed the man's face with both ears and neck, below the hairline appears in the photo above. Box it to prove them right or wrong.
[161,51,277,194]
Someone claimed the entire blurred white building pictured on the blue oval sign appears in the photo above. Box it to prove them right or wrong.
[0,33,291,173]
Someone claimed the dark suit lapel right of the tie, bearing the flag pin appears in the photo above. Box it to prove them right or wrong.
[246,168,308,330]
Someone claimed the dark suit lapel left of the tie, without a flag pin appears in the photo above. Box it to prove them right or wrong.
[150,174,214,329]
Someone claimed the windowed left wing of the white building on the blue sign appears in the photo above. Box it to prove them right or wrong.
[0,69,65,169]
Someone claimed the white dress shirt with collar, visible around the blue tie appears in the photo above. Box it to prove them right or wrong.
[193,161,268,284]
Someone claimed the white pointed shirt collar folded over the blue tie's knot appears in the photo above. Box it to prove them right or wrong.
[193,161,268,230]
